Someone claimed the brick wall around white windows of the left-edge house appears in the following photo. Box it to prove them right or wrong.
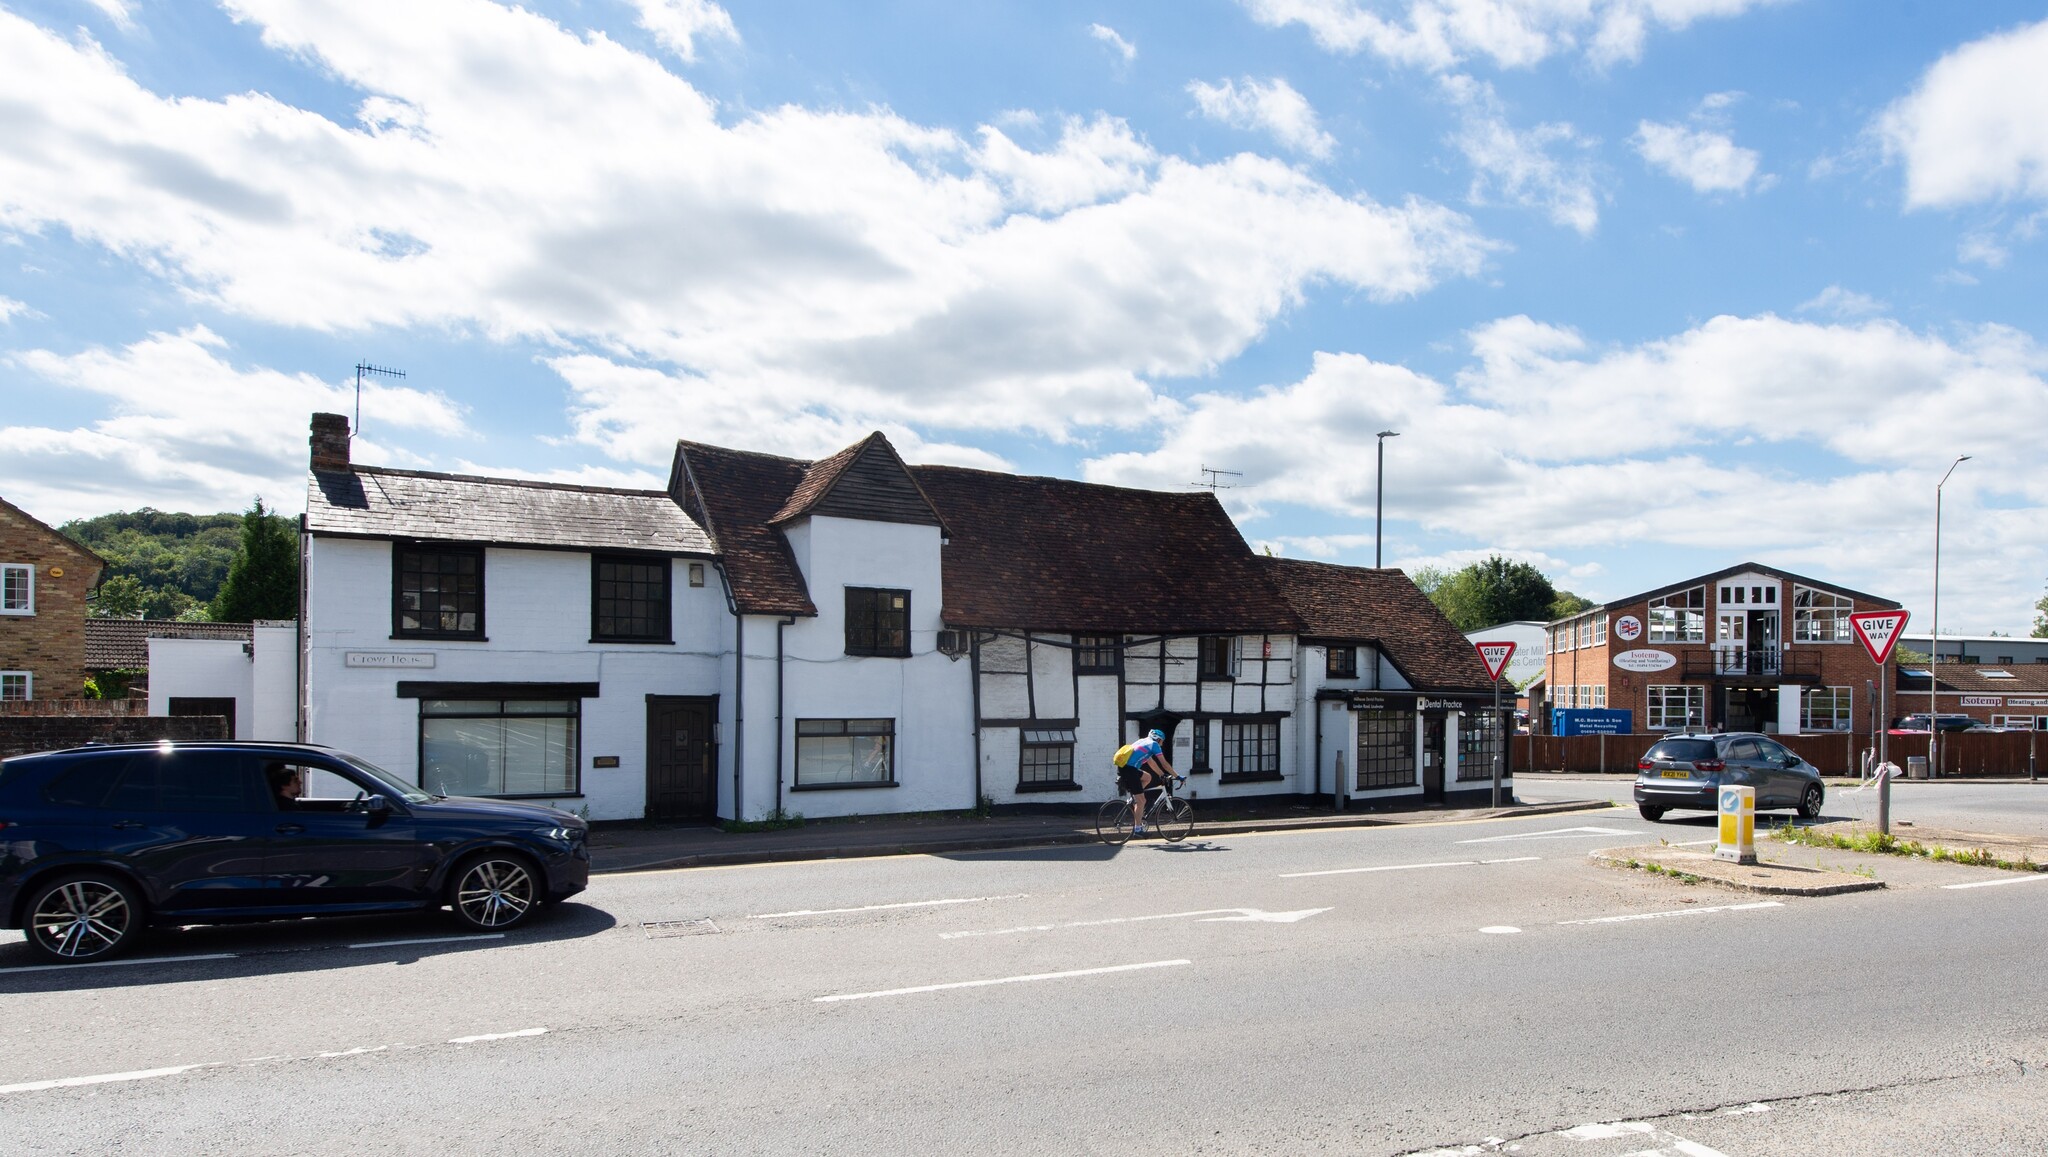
[0,504,100,698]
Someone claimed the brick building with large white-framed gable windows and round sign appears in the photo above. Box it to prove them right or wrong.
[1544,563,1898,733]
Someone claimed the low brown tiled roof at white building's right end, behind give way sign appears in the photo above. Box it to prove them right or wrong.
[1262,559,1493,690]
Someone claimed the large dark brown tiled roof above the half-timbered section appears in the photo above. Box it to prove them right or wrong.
[911,467,1298,635]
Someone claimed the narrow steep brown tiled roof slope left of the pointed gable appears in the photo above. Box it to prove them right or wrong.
[670,442,823,614]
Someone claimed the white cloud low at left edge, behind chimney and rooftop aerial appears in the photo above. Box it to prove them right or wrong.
[0,326,465,520]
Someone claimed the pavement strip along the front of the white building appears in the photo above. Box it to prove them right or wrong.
[590,799,1614,874]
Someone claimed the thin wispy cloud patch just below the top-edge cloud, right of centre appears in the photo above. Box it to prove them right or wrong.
[1442,76,1599,235]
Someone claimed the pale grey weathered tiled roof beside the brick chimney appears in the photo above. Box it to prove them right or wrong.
[305,467,713,555]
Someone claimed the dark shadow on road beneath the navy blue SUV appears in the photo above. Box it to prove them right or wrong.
[0,903,618,993]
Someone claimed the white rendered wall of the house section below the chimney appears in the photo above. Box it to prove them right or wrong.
[305,537,733,819]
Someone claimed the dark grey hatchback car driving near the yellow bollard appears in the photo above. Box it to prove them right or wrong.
[1636,731,1827,823]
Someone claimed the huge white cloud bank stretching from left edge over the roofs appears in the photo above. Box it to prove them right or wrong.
[0,0,1491,465]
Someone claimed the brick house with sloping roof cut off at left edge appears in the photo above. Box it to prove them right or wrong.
[0,491,106,700]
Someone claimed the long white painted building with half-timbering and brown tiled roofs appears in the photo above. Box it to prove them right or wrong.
[288,416,1485,821]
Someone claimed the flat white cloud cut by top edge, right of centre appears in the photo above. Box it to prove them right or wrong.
[1239,0,1776,70]
